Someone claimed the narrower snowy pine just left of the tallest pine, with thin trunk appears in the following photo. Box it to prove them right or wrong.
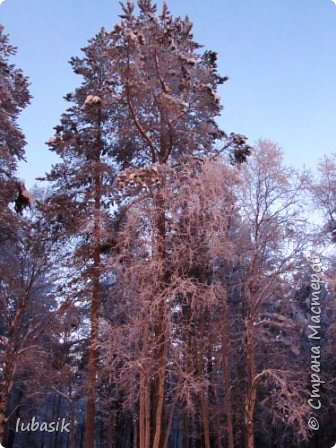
[44,29,114,448]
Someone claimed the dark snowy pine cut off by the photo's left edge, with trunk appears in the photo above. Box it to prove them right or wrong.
[0,25,31,443]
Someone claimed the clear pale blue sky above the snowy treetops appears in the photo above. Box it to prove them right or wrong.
[0,0,336,186]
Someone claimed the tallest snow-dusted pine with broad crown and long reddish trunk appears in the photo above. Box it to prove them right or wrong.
[103,0,249,448]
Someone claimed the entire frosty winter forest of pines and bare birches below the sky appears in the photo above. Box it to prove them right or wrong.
[0,0,336,448]
